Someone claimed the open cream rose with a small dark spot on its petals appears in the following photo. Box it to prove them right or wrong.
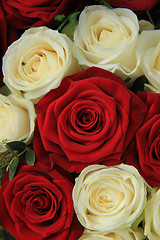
[3,27,79,102]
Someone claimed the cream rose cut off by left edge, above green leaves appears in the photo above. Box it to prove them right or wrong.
[0,94,36,152]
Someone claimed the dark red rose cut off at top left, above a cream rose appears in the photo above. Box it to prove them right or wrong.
[2,0,84,29]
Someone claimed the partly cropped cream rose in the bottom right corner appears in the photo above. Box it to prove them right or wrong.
[144,188,160,240]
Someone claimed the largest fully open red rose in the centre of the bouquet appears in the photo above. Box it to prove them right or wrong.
[33,67,146,172]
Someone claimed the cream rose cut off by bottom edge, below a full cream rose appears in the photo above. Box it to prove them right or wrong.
[78,228,144,240]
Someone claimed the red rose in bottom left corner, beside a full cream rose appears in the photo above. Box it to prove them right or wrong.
[0,163,83,240]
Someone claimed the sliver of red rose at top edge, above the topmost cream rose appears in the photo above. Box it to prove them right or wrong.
[107,0,159,11]
